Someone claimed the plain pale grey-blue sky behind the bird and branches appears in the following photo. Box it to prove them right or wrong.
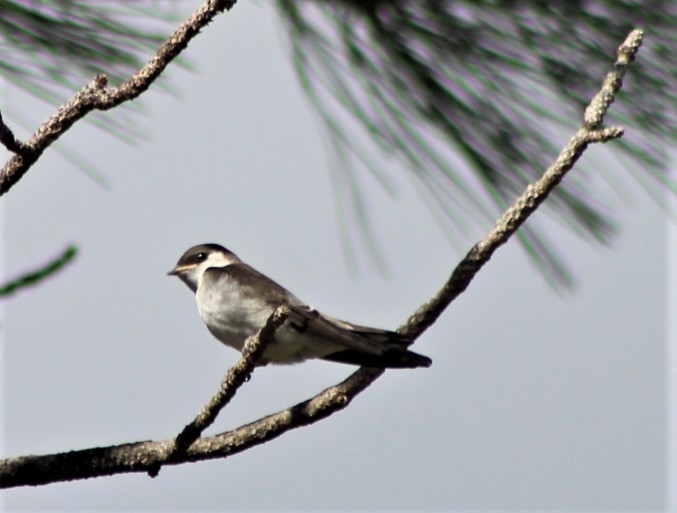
[0,2,677,511]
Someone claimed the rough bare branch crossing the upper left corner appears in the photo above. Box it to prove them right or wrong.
[0,0,236,196]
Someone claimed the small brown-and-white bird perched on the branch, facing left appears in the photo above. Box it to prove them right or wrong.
[167,244,432,368]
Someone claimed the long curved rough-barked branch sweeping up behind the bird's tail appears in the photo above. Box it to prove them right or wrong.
[0,30,643,488]
